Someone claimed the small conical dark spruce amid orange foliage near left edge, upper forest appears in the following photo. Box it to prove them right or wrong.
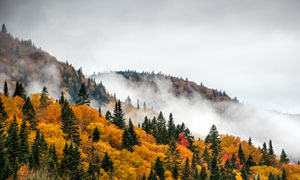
[22,97,37,130]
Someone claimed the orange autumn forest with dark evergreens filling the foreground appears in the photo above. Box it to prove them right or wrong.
[0,82,300,180]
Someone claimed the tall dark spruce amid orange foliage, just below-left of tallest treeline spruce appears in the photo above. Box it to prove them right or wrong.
[61,103,80,145]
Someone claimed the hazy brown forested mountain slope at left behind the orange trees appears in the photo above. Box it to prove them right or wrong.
[0,32,113,104]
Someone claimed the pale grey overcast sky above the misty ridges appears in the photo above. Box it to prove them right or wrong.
[0,0,300,113]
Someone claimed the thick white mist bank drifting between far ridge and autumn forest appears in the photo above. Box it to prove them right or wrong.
[96,73,300,162]
